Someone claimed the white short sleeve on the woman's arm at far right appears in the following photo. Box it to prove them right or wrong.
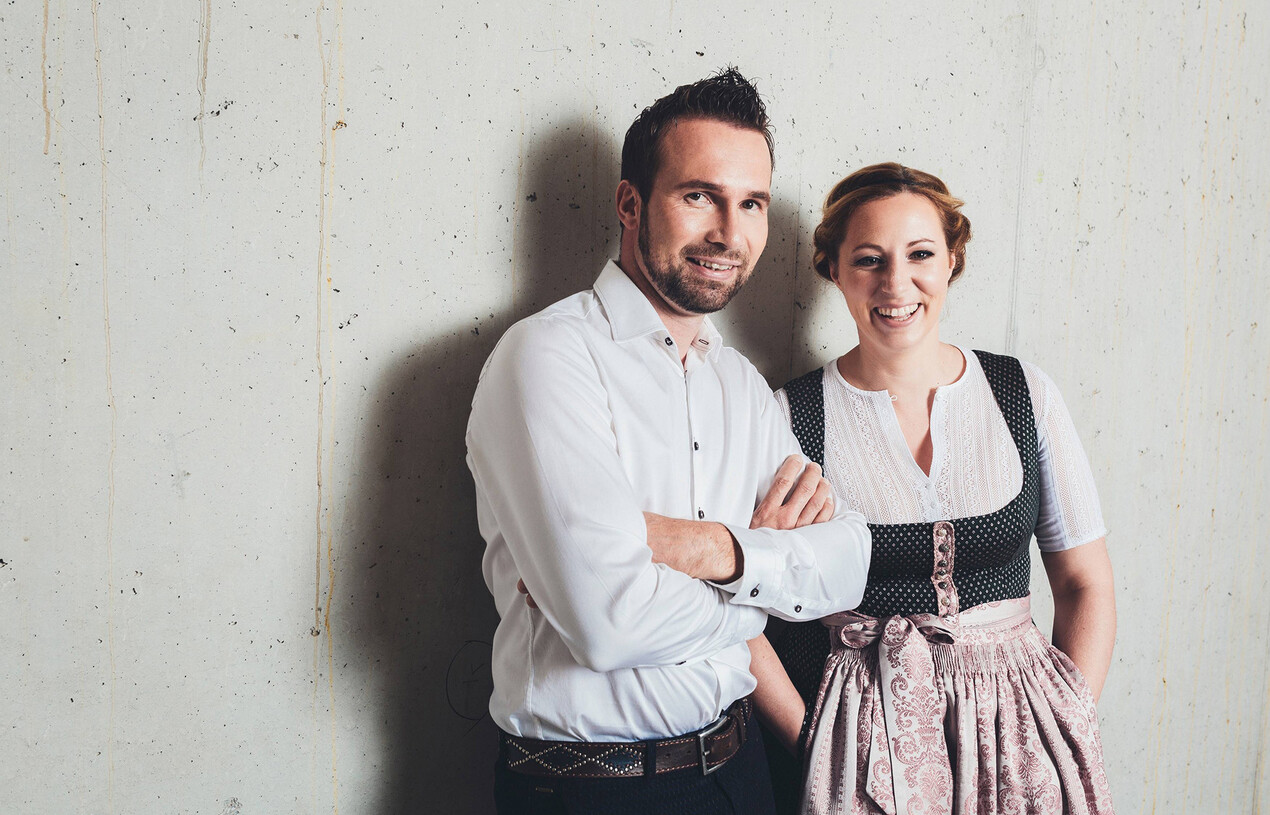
[1024,362,1107,552]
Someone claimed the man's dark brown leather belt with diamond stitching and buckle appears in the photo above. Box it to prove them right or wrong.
[500,696,753,778]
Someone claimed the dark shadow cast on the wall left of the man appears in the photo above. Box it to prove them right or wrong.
[343,118,620,815]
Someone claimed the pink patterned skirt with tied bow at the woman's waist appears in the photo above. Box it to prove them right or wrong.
[803,598,1113,815]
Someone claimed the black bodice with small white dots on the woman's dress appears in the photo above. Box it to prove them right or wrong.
[768,350,1040,699]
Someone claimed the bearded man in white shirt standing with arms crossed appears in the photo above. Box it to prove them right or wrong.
[467,69,870,815]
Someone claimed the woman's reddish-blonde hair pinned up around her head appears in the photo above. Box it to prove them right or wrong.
[812,161,970,283]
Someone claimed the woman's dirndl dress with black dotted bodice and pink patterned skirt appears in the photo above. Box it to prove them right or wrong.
[773,352,1113,815]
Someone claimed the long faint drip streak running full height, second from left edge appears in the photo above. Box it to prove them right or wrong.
[93,0,119,812]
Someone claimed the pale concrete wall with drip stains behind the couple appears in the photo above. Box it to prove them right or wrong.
[0,0,1270,815]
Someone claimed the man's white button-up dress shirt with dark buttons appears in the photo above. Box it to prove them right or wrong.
[467,262,870,741]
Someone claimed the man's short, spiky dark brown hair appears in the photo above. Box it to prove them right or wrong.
[622,66,776,201]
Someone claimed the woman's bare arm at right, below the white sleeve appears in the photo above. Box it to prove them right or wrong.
[1046,538,1115,701]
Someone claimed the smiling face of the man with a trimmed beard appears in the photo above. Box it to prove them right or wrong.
[639,119,772,315]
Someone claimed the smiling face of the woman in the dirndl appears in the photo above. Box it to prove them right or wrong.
[829,193,955,350]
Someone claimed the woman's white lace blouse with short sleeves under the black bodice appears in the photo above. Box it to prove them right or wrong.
[776,348,1106,552]
